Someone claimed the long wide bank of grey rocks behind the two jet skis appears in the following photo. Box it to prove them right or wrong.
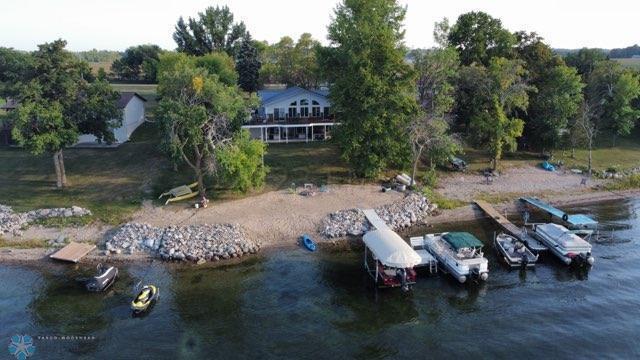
[105,223,260,263]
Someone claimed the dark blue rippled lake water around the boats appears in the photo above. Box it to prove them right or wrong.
[0,199,640,359]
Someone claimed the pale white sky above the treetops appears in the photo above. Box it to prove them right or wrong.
[0,0,640,51]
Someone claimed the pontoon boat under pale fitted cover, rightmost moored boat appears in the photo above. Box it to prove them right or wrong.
[533,224,595,265]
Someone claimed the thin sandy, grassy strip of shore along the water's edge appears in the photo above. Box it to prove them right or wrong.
[0,189,640,268]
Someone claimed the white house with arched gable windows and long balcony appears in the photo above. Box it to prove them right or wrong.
[242,87,339,143]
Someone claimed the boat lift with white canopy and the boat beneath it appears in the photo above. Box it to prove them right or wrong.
[362,228,422,291]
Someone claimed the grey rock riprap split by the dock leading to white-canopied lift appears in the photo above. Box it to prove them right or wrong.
[320,193,437,238]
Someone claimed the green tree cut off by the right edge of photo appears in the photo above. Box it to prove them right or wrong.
[586,60,640,145]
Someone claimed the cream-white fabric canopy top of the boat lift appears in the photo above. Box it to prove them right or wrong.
[362,229,422,268]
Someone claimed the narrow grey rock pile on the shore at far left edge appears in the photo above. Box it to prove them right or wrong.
[0,205,91,236]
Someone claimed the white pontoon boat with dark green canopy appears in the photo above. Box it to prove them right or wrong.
[424,232,489,283]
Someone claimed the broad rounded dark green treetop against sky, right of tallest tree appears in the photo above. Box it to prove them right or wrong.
[448,11,515,66]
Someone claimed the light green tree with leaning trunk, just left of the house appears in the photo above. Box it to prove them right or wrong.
[156,57,249,198]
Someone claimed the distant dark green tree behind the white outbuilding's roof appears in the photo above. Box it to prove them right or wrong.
[111,45,162,82]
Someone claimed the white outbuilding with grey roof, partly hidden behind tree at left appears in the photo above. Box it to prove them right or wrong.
[76,92,147,146]
